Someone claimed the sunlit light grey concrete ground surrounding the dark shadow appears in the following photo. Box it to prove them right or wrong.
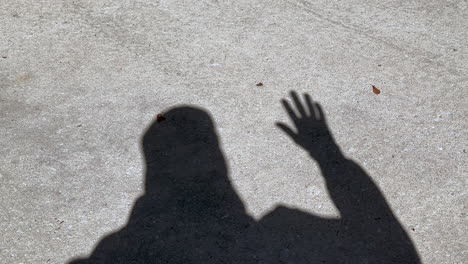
[0,0,468,264]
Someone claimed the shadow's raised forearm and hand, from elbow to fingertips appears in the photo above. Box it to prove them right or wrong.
[277,92,419,263]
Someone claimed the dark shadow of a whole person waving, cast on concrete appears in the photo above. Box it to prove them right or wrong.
[71,96,420,264]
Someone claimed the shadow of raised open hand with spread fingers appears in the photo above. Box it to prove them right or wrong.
[276,91,339,161]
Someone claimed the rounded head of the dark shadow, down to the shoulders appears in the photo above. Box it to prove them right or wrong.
[142,106,240,212]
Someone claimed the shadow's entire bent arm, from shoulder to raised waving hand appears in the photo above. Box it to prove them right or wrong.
[243,92,420,264]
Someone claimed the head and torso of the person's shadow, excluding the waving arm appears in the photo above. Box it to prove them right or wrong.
[67,106,253,264]
